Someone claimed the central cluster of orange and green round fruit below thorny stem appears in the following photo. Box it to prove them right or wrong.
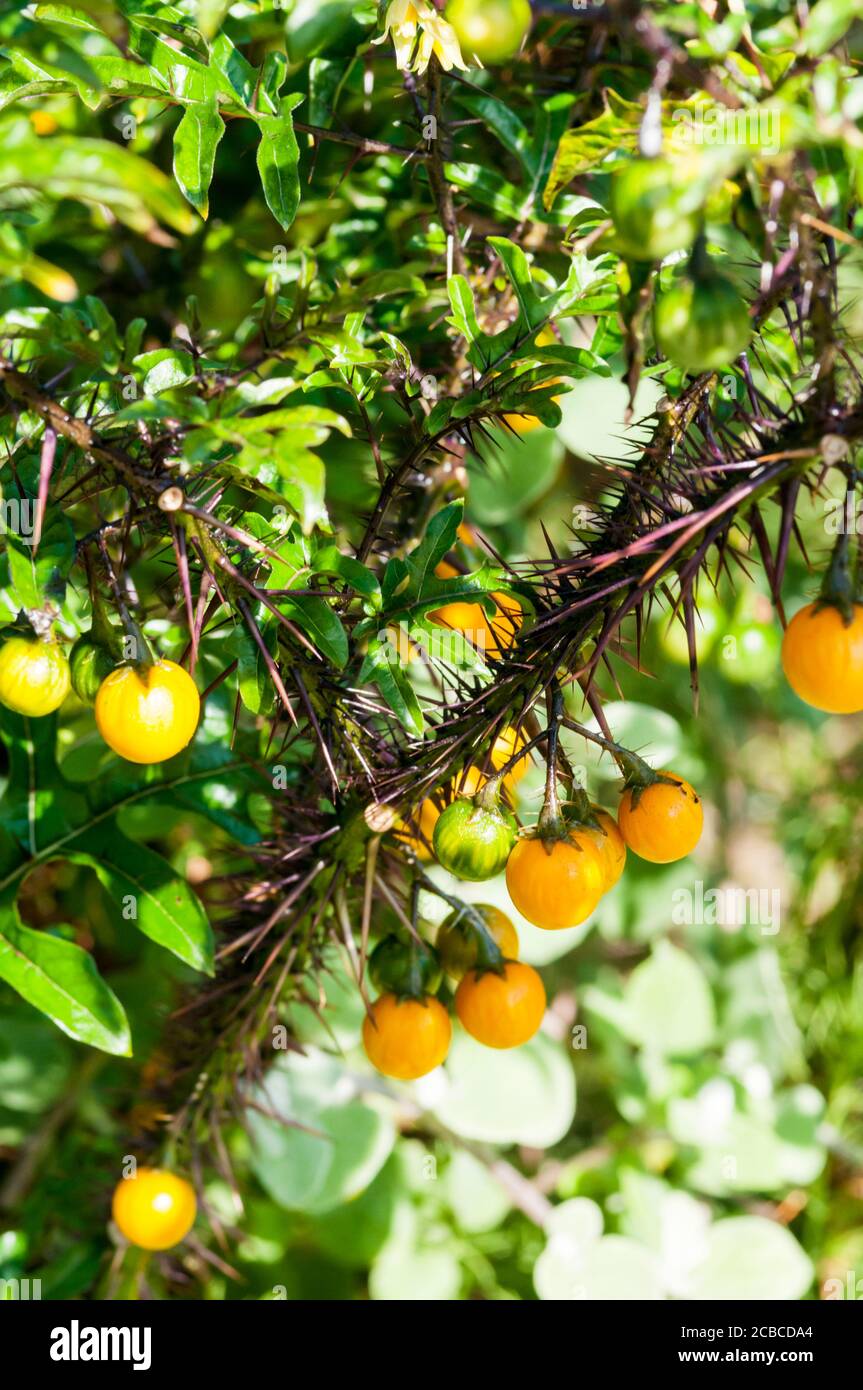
[363,728,703,1080]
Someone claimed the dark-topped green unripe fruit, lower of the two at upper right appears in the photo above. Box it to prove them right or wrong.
[653,271,752,373]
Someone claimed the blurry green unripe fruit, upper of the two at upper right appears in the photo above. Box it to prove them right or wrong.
[609,158,702,261]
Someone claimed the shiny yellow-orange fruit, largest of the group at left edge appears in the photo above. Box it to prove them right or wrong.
[94,660,200,763]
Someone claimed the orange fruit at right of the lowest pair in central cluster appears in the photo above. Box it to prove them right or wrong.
[456,960,546,1048]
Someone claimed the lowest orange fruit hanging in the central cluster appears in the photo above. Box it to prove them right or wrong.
[363,994,453,1081]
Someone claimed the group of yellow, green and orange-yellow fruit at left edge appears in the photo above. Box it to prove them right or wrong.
[0,634,200,763]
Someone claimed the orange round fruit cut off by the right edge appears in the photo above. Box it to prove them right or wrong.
[782,603,863,714]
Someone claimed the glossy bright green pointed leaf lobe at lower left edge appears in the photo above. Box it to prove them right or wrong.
[0,892,132,1056]
